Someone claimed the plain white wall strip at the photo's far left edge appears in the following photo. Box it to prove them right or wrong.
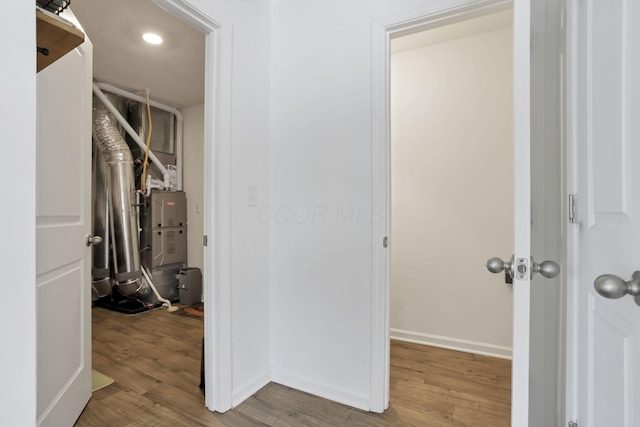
[0,0,36,426]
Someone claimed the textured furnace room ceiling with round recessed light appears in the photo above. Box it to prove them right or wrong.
[70,0,205,108]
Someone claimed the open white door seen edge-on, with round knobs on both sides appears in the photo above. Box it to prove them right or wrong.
[511,0,564,427]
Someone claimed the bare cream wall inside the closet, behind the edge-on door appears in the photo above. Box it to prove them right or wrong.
[391,22,514,357]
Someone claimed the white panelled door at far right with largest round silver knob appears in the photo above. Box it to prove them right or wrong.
[574,0,640,427]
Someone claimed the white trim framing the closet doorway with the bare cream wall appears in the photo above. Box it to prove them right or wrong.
[369,0,513,412]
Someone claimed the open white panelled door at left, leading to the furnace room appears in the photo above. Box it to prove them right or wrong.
[35,14,93,426]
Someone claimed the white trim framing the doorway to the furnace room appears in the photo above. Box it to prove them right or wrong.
[153,0,233,412]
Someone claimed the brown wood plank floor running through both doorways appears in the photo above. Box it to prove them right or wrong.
[76,308,511,427]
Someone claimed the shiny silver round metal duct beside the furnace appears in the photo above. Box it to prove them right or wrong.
[93,96,143,295]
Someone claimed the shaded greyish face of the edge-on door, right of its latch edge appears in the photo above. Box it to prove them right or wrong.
[529,0,568,427]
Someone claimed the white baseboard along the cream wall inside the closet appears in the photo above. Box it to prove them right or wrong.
[390,328,513,359]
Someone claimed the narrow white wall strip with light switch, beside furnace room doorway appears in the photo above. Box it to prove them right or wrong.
[189,0,271,404]
